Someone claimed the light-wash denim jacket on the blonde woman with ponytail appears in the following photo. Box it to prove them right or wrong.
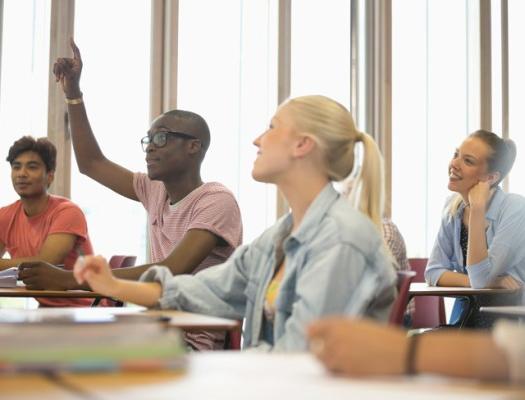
[141,184,396,351]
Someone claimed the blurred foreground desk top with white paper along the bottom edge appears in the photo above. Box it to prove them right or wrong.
[56,352,525,400]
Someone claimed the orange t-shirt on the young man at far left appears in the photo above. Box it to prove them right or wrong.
[0,195,93,307]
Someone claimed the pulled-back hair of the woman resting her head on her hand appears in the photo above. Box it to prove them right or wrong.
[470,130,516,186]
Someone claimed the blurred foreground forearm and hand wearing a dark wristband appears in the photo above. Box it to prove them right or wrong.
[308,317,512,383]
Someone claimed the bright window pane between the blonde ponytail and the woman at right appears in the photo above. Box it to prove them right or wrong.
[392,0,479,257]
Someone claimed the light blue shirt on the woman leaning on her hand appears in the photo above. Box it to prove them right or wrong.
[425,188,525,289]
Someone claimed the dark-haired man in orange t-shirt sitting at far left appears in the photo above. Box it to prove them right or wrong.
[0,136,93,306]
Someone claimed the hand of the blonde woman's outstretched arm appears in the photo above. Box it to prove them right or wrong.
[73,256,117,296]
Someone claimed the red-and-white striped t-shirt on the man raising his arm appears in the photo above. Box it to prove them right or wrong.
[133,173,242,350]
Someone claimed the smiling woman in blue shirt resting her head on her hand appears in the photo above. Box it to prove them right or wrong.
[425,130,525,326]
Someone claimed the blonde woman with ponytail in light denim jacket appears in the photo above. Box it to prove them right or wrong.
[75,96,395,351]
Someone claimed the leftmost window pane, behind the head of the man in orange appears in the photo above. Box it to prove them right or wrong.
[0,0,51,205]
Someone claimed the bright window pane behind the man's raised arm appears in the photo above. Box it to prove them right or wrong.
[71,0,151,263]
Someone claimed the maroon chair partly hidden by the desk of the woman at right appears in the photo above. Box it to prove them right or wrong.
[408,258,446,329]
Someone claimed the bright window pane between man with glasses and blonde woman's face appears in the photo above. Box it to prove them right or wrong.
[177,0,277,243]
